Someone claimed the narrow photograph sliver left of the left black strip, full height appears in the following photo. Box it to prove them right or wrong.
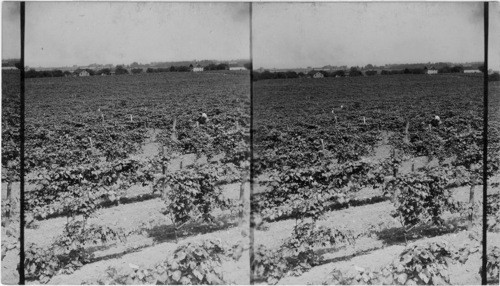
[0,2,21,284]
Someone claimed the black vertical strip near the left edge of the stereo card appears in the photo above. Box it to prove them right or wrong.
[18,2,25,285]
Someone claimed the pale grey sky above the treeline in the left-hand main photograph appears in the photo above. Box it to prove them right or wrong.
[25,2,250,67]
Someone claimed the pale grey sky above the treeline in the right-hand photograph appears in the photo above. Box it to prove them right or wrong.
[252,2,500,69]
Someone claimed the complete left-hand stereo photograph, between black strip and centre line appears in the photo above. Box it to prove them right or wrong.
[23,2,251,285]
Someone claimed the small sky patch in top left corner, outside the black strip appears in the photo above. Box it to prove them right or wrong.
[2,2,21,59]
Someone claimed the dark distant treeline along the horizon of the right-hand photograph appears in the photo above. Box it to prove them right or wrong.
[253,66,484,80]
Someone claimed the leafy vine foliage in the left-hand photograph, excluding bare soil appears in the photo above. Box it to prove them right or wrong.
[23,72,250,284]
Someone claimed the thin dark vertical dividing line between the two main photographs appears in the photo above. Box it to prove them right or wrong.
[249,2,255,284]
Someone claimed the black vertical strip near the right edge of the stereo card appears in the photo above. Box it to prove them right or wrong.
[481,2,489,285]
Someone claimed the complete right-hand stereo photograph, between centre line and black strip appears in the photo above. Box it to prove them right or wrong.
[251,3,492,285]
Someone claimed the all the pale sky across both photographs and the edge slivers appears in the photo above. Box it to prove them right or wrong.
[2,1,500,70]
